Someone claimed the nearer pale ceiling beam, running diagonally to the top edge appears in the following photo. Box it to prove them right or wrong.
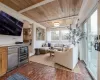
[19,0,54,13]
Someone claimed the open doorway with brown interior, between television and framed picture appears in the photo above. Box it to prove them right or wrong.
[23,22,33,56]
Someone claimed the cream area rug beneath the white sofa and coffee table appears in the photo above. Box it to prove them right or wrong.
[30,54,94,80]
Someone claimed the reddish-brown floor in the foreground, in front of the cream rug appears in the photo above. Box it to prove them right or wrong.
[0,62,85,80]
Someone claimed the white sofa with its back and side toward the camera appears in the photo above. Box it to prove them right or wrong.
[54,45,78,69]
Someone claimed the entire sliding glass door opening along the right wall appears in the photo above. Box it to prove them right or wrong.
[83,10,98,79]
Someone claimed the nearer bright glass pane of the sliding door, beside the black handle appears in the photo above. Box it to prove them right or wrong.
[87,10,98,79]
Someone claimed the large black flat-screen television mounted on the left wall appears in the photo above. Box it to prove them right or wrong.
[0,11,23,36]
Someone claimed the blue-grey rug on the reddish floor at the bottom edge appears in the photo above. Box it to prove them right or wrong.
[7,73,29,80]
